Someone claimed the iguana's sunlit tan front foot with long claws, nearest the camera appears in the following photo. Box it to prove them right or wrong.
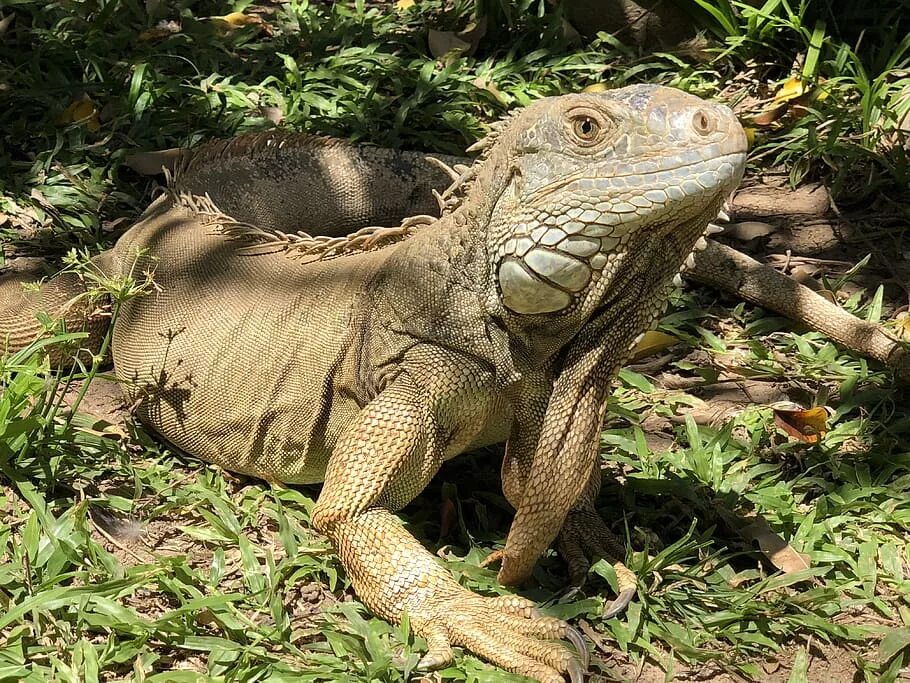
[411,591,588,683]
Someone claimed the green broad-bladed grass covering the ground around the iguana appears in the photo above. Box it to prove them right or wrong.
[0,0,910,682]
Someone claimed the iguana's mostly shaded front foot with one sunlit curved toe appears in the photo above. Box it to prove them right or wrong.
[559,510,638,619]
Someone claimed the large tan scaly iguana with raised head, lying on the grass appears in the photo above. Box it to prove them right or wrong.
[0,86,764,682]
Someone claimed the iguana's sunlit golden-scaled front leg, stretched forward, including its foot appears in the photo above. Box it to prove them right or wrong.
[313,375,587,683]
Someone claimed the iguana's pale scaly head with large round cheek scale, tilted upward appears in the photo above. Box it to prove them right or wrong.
[485,85,747,323]
